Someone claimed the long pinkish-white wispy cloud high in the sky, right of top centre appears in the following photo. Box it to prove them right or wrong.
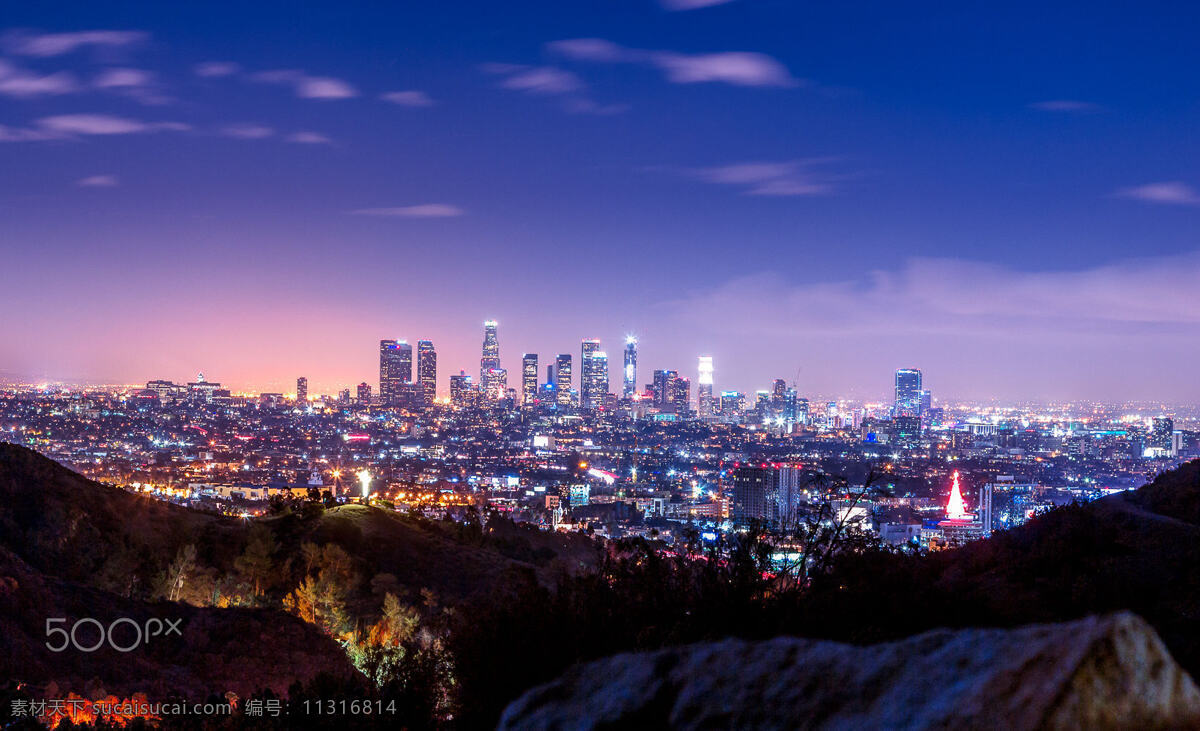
[546,38,805,88]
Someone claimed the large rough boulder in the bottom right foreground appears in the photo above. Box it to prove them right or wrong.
[500,612,1200,729]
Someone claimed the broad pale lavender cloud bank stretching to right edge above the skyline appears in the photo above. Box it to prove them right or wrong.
[680,253,1200,337]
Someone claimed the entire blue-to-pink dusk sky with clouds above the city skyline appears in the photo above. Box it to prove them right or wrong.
[0,0,1200,401]
